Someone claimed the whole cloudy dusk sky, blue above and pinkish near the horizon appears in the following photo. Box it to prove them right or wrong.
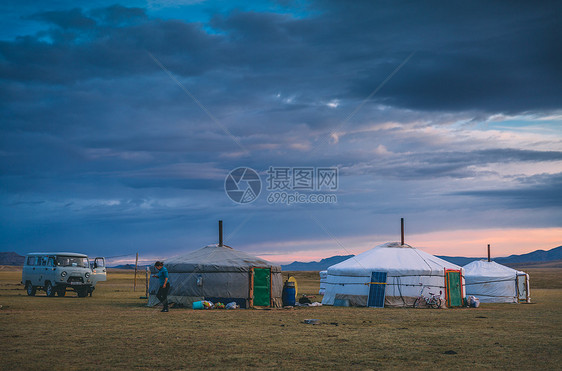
[0,0,562,263]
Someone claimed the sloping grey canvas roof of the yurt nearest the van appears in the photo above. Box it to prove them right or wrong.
[164,245,281,273]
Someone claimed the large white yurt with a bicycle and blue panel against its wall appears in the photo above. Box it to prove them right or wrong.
[322,242,464,307]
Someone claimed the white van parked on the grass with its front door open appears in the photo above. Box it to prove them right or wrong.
[21,252,106,297]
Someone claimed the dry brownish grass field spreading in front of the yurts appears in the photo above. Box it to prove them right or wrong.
[0,268,562,370]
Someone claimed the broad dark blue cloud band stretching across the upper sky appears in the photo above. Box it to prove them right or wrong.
[0,2,562,112]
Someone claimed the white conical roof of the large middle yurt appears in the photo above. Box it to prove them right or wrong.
[328,242,461,277]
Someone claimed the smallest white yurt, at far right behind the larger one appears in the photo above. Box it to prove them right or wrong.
[463,260,531,303]
